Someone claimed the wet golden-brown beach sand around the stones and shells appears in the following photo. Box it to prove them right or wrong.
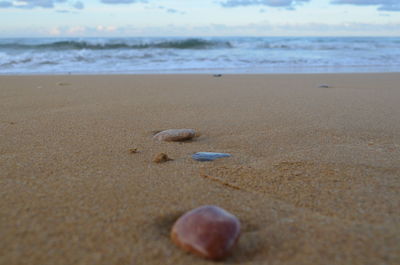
[0,73,400,265]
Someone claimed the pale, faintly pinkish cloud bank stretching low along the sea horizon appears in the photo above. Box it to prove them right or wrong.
[0,22,400,37]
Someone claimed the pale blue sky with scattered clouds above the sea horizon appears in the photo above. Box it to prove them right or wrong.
[0,0,400,37]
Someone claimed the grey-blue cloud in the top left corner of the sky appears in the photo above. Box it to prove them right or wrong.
[0,0,84,9]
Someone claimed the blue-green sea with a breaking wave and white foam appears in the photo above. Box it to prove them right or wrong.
[0,37,400,75]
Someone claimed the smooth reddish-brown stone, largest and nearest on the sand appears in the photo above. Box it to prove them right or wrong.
[171,205,240,260]
